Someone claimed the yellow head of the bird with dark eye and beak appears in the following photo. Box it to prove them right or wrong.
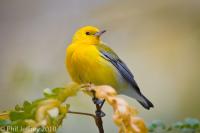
[72,26,106,44]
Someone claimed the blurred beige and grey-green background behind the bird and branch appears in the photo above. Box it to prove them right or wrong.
[0,0,200,133]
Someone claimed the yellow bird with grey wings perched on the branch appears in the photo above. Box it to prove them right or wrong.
[66,26,153,109]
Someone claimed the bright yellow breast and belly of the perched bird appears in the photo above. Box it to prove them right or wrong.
[68,45,117,85]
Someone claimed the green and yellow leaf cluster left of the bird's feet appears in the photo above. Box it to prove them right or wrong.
[0,84,79,133]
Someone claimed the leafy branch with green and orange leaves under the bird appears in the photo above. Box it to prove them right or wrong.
[0,84,147,133]
